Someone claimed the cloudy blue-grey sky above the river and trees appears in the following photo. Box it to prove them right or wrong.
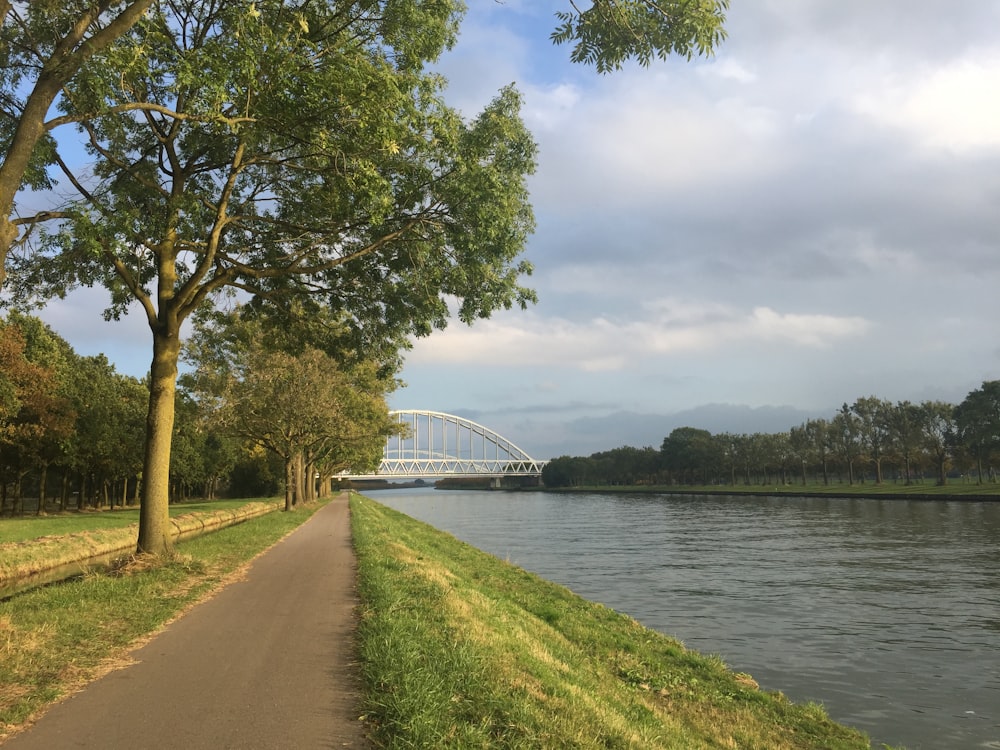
[35,0,1000,459]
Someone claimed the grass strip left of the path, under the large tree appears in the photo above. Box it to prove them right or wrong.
[0,504,322,739]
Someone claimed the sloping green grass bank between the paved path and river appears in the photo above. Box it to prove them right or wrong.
[351,495,869,750]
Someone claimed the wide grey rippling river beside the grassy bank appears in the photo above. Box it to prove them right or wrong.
[366,489,1000,750]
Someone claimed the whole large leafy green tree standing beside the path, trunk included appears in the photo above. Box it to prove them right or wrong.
[12,2,535,553]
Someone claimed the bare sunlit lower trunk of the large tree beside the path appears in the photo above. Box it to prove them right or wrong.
[137,324,180,555]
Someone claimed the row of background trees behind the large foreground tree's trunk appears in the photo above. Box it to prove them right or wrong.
[0,312,394,515]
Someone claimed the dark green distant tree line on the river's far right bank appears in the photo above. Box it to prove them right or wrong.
[542,381,1000,487]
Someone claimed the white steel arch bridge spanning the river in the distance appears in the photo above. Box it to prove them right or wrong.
[342,409,546,479]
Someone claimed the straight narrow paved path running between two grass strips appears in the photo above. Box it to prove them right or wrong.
[3,496,365,750]
